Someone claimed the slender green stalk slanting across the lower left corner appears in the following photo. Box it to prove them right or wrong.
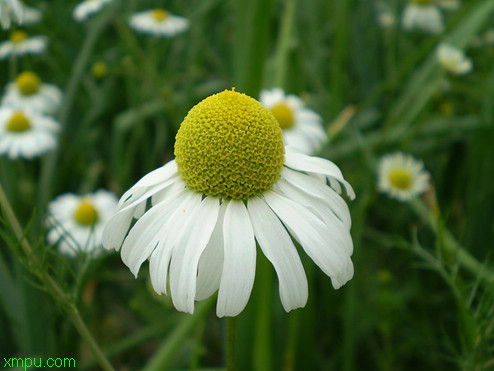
[0,184,114,371]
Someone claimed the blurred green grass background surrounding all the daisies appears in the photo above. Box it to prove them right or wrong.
[0,0,494,371]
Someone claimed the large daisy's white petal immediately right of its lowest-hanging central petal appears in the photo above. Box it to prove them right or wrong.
[247,198,309,312]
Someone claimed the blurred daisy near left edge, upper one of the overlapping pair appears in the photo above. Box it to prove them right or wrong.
[2,71,62,114]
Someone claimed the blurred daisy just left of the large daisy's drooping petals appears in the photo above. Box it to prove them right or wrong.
[47,190,118,256]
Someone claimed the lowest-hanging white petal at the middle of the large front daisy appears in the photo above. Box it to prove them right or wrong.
[216,200,256,317]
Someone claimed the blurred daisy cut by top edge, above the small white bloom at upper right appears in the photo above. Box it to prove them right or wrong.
[402,0,444,34]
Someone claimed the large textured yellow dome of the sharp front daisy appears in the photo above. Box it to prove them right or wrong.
[175,90,285,199]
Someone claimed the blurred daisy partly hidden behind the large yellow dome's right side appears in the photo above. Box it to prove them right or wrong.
[261,88,327,154]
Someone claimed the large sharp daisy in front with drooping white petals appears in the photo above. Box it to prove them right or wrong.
[103,90,355,317]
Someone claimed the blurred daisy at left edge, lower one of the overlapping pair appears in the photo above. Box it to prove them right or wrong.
[0,107,59,159]
